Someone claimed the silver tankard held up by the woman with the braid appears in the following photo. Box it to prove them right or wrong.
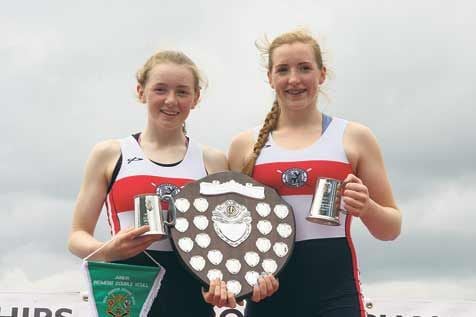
[306,178,345,226]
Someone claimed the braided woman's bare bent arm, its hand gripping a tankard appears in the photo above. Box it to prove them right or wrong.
[343,123,402,240]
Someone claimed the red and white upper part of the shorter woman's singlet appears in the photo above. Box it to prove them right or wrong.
[106,136,207,251]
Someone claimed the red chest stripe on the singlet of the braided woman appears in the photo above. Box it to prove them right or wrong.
[253,160,352,196]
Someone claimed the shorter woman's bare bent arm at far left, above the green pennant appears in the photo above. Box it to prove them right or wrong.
[68,141,158,261]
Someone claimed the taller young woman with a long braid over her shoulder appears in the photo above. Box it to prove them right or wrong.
[228,30,401,317]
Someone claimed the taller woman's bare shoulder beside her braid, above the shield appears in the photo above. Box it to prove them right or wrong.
[228,129,256,171]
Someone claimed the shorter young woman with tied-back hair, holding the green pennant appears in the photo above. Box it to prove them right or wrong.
[68,51,236,317]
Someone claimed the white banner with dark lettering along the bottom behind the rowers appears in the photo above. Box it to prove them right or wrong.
[0,291,476,317]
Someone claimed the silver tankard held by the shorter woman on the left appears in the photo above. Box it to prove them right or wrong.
[134,194,176,238]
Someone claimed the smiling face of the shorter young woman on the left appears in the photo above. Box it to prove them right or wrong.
[137,63,200,129]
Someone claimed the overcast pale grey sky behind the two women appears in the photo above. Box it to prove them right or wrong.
[0,0,476,301]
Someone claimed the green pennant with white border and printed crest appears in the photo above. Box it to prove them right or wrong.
[83,261,165,317]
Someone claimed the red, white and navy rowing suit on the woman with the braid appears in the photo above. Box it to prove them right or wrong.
[246,114,366,317]
